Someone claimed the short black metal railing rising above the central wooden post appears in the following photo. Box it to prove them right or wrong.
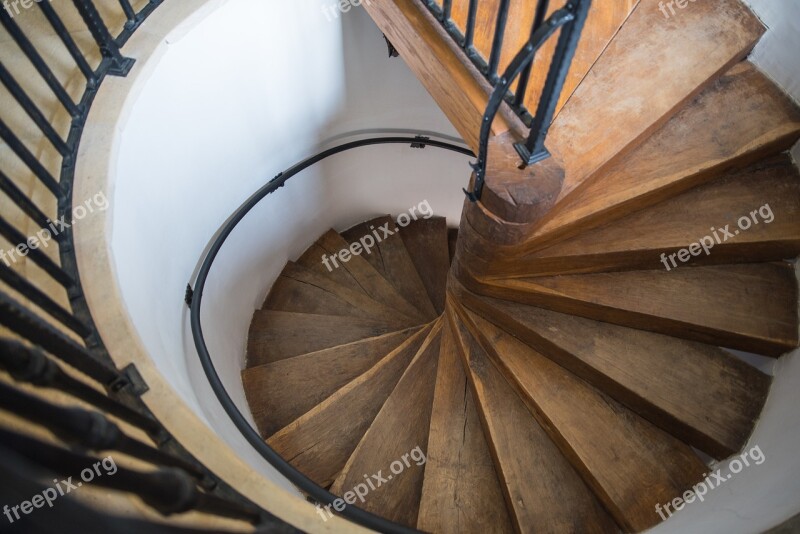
[422,0,592,202]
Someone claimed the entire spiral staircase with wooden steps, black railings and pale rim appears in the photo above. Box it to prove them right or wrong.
[0,0,800,533]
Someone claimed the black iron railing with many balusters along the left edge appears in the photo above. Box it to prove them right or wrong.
[0,0,297,532]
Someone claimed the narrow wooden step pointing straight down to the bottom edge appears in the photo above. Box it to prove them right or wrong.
[417,322,514,534]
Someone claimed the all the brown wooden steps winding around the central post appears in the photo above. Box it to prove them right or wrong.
[242,0,800,532]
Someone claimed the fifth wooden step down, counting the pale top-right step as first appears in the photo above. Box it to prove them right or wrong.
[459,290,771,459]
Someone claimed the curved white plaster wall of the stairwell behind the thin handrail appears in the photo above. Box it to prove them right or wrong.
[111,0,469,494]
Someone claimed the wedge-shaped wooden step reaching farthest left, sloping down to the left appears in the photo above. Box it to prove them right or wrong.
[242,327,420,439]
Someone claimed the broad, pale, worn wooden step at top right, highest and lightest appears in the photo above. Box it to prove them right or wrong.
[547,0,764,199]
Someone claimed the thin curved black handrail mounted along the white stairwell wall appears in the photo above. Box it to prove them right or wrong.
[187,136,475,534]
